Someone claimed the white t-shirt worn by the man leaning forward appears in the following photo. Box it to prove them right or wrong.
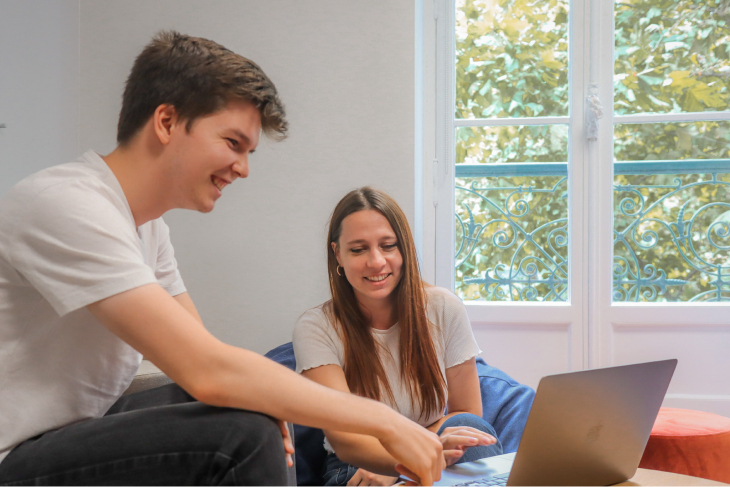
[0,151,185,461]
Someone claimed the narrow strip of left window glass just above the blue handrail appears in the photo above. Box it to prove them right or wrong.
[456,125,568,164]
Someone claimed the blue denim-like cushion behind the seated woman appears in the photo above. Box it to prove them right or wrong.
[266,342,535,487]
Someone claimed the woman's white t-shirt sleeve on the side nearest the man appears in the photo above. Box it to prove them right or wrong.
[293,308,344,374]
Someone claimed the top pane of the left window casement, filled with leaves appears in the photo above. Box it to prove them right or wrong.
[455,0,569,118]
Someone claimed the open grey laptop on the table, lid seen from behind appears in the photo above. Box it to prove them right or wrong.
[426,359,677,487]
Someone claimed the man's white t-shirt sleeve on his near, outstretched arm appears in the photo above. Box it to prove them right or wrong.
[8,182,157,316]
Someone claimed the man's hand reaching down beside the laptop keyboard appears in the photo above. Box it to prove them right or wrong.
[379,416,446,487]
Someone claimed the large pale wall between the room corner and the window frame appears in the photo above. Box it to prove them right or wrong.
[79,0,415,353]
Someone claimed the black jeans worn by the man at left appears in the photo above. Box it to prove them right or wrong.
[0,384,287,487]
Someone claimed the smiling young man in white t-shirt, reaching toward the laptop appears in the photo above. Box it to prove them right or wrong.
[0,32,456,486]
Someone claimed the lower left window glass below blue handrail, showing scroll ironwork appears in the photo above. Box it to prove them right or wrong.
[456,173,568,301]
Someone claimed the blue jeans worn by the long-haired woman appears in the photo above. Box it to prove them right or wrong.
[324,413,502,487]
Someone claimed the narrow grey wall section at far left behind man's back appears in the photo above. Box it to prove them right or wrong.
[0,0,79,196]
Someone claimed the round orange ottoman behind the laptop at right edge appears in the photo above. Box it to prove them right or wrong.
[639,408,730,483]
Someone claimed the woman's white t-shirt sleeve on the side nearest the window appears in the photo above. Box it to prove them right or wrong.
[431,289,482,369]
